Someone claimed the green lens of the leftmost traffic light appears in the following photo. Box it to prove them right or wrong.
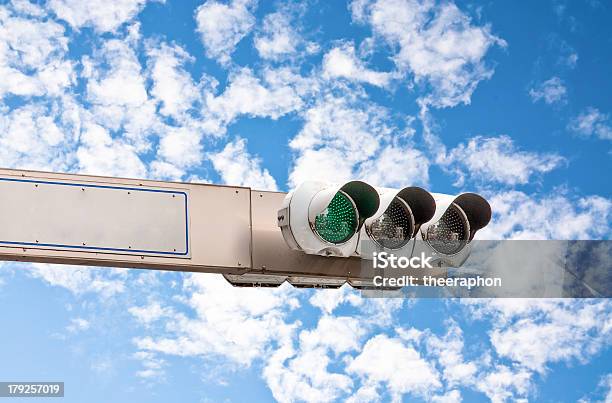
[315,192,358,244]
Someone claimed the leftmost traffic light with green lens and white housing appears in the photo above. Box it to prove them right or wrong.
[277,181,380,257]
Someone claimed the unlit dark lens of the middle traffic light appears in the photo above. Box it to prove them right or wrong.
[366,197,414,249]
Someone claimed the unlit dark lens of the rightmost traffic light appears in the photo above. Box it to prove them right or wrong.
[424,203,470,255]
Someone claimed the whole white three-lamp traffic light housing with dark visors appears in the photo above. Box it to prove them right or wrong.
[277,181,491,266]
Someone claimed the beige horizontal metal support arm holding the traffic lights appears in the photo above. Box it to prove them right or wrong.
[0,169,396,283]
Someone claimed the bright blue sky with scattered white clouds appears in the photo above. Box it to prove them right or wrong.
[0,0,612,402]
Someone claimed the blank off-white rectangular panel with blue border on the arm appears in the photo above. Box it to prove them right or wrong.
[0,177,190,258]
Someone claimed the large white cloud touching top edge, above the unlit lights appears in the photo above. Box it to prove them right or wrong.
[351,0,506,107]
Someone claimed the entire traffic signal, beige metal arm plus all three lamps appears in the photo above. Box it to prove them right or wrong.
[0,168,491,289]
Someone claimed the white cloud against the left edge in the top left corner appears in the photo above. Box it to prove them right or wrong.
[0,4,75,99]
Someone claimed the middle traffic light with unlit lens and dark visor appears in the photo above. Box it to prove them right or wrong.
[357,187,436,254]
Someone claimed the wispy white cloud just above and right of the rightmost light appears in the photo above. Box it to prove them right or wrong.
[445,135,565,186]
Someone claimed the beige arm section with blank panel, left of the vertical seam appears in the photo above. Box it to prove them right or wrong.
[0,168,251,273]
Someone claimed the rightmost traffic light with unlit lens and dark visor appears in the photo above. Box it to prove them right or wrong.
[413,193,491,267]
